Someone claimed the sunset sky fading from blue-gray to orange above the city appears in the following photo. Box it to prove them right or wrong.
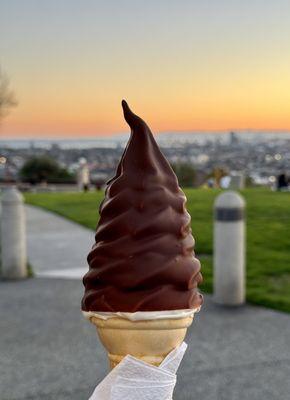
[0,0,290,138]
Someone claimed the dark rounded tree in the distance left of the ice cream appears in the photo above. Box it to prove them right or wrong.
[20,156,74,184]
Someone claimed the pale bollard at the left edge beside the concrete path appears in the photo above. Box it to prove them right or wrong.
[0,187,27,279]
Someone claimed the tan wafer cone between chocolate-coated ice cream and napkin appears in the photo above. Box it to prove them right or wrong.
[90,316,193,369]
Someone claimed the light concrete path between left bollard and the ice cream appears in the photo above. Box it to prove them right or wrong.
[26,206,94,279]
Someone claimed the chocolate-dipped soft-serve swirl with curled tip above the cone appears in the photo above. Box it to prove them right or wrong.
[82,100,202,312]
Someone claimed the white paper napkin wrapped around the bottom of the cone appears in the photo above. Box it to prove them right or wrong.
[89,342,187,400]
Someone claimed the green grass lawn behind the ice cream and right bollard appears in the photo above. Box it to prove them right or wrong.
[25,189,290,312]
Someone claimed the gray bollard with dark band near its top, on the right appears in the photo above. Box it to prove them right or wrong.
[214,191,245,306]
